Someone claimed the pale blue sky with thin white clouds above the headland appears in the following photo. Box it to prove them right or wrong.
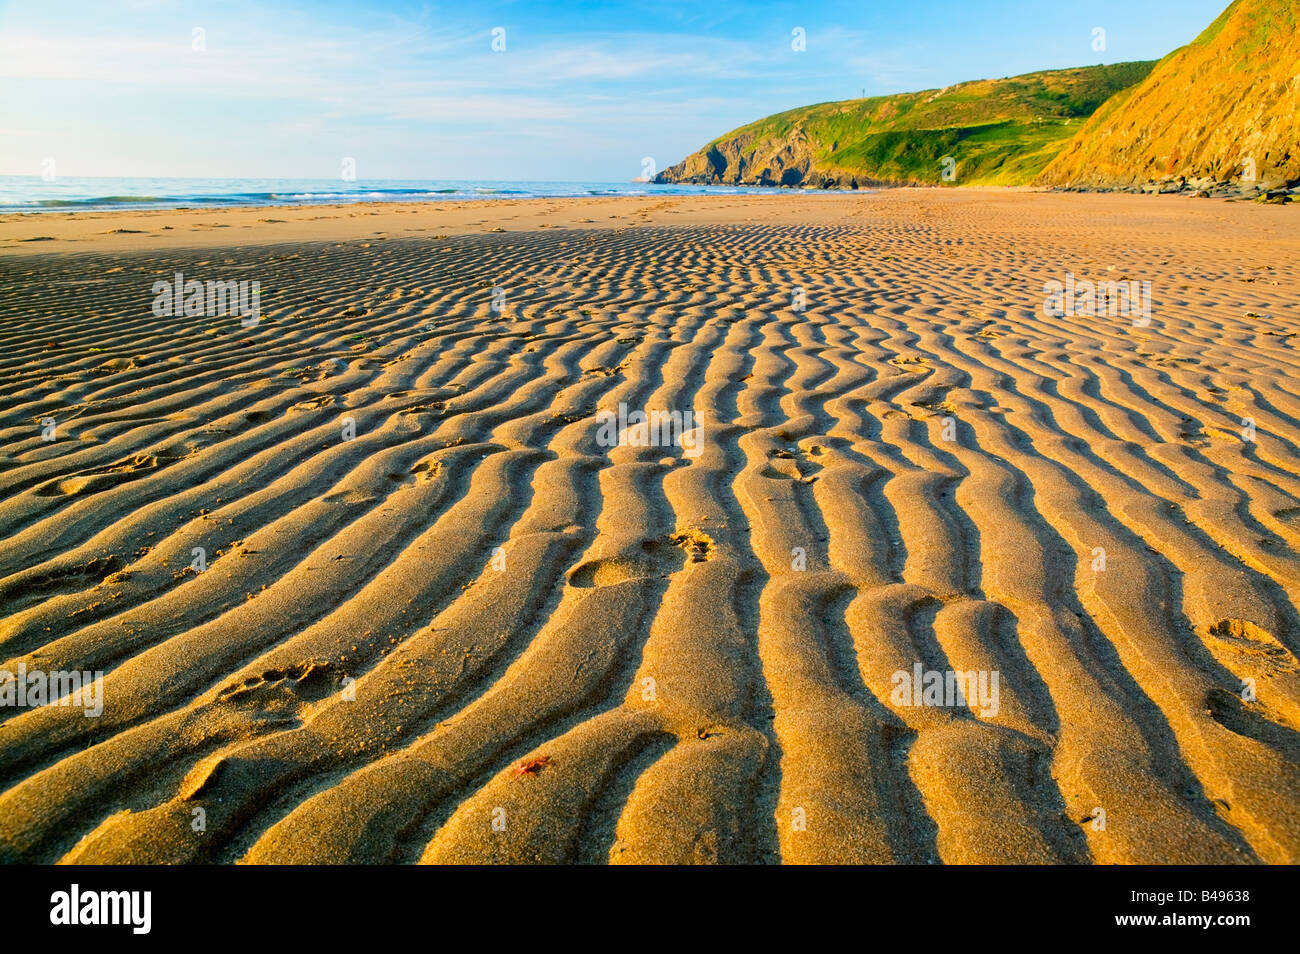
[0,0,1227,182]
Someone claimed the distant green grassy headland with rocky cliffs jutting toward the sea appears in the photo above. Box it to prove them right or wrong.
[655,62,1153,188]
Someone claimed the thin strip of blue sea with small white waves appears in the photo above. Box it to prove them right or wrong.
[0,175,819,212]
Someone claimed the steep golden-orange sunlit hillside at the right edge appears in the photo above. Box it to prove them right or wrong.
[1039,0,1300,190]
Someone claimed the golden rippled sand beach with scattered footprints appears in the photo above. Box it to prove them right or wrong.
[0,191,1300,863]
